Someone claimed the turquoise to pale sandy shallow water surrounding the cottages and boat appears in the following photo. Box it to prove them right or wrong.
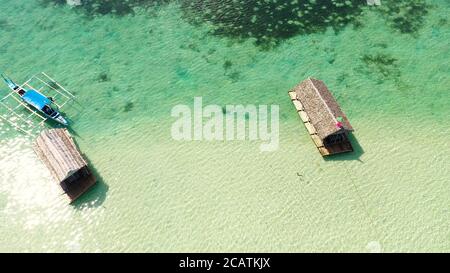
[0,0,450,252]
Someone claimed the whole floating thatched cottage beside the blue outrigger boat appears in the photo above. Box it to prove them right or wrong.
[34,129,96,202]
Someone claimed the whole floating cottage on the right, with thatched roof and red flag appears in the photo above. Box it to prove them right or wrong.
[289,78,353,156]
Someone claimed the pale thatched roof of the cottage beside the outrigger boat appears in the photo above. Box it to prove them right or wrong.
[35,129,87,182]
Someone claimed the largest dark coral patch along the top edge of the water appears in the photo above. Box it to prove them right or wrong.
[181,0,364,47]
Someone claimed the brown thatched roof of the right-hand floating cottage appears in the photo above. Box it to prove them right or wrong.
[292,78,353,140]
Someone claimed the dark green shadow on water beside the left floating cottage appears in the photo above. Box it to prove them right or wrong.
[71,155,109,210]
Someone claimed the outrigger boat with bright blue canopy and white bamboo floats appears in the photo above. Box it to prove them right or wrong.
[0,72,75,134]
